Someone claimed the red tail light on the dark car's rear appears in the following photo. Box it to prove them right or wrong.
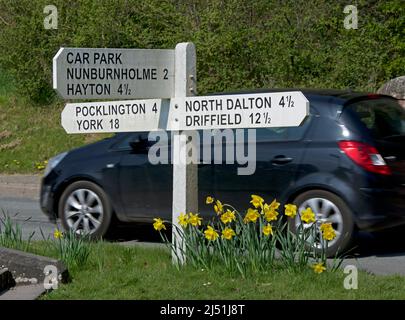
[339,141,391,175]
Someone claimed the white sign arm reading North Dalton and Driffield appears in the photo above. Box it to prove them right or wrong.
[167,91,309,130]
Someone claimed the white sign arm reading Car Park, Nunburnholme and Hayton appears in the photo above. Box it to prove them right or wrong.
[53,48,174,99]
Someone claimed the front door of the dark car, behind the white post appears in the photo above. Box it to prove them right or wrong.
[115,132,214,220]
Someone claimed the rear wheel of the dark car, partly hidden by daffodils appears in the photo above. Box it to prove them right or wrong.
[289,190,354,257]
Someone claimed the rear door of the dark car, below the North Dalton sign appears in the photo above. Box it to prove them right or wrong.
[214,119,309,210]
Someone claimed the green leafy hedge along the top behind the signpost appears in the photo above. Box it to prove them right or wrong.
[0,0,405,102]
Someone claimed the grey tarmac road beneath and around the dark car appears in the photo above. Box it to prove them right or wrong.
[0,176,405,275]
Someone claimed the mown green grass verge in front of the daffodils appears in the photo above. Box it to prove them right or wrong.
[19,242,405,300]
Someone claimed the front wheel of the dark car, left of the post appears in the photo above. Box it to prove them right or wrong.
[59,181,112,239]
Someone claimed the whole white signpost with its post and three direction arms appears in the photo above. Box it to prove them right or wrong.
[53,43,309,263]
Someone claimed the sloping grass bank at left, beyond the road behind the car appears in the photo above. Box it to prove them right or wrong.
[0,70,106,174]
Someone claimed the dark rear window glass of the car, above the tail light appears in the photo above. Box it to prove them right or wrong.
[342,98,405,140]
